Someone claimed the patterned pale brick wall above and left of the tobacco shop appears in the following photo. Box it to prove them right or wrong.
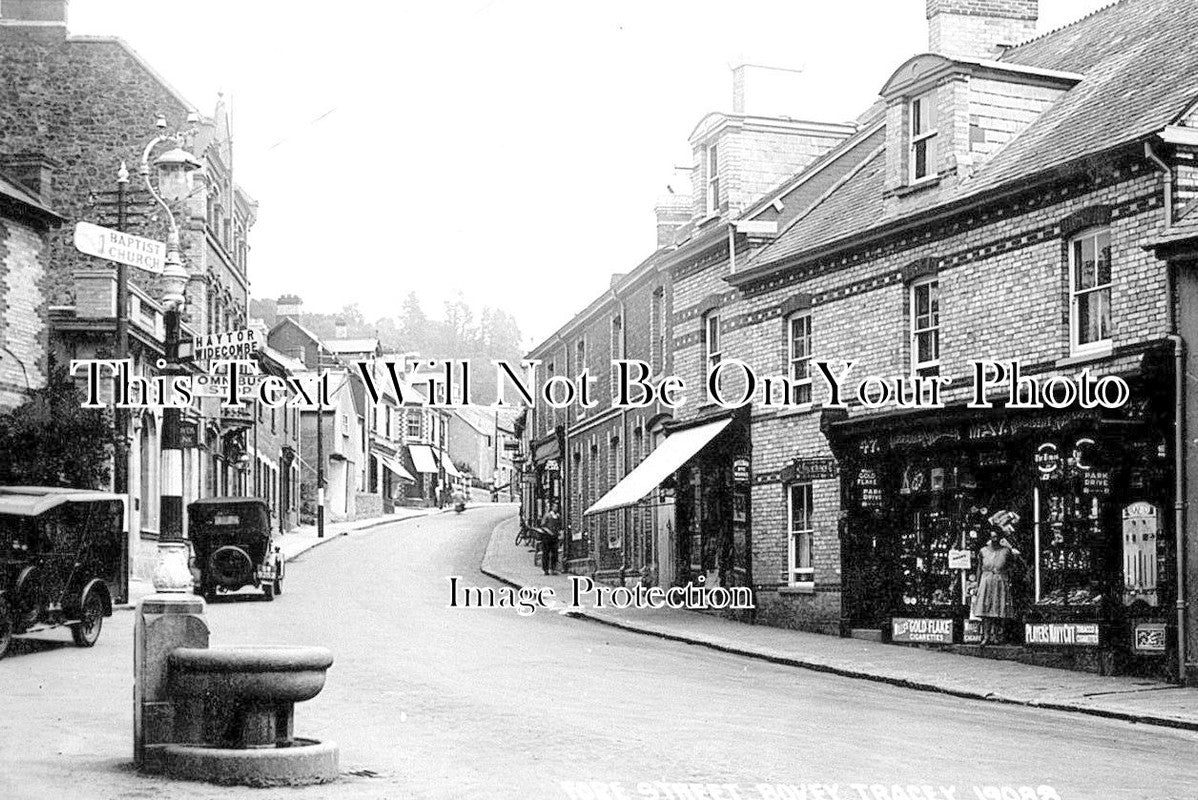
[724,154,1167,630]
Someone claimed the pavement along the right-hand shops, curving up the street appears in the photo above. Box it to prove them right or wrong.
[480,519,1198,731]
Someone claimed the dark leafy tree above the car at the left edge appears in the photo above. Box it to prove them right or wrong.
[0,364,113,489]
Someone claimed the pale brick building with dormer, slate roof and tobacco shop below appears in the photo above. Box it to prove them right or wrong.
[722,0,1198,674]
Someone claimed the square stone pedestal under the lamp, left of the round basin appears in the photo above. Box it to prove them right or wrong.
[133,593,208,768]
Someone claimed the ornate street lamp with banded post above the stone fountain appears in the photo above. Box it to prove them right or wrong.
[139,115,204,592]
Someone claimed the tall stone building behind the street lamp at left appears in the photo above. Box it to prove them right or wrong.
[0,0,256,576]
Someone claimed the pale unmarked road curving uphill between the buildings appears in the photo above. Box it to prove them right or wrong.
[7,507,1198,800]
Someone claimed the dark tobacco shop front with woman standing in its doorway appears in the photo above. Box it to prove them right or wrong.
[825,383,1176,677]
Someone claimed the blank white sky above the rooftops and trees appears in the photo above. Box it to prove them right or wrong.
[69,0,1109,345]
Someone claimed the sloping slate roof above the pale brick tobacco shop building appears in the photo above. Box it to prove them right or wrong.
[738,0,1198,276]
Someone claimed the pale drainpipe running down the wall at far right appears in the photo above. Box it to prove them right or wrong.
[1144,141,1187,684]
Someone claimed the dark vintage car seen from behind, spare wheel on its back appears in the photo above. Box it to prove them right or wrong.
[187,497,284,600]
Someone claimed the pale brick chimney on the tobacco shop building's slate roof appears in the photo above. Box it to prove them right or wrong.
[927,0,1040,60]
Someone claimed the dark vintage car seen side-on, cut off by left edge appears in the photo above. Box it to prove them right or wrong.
[0,486,125,656]
